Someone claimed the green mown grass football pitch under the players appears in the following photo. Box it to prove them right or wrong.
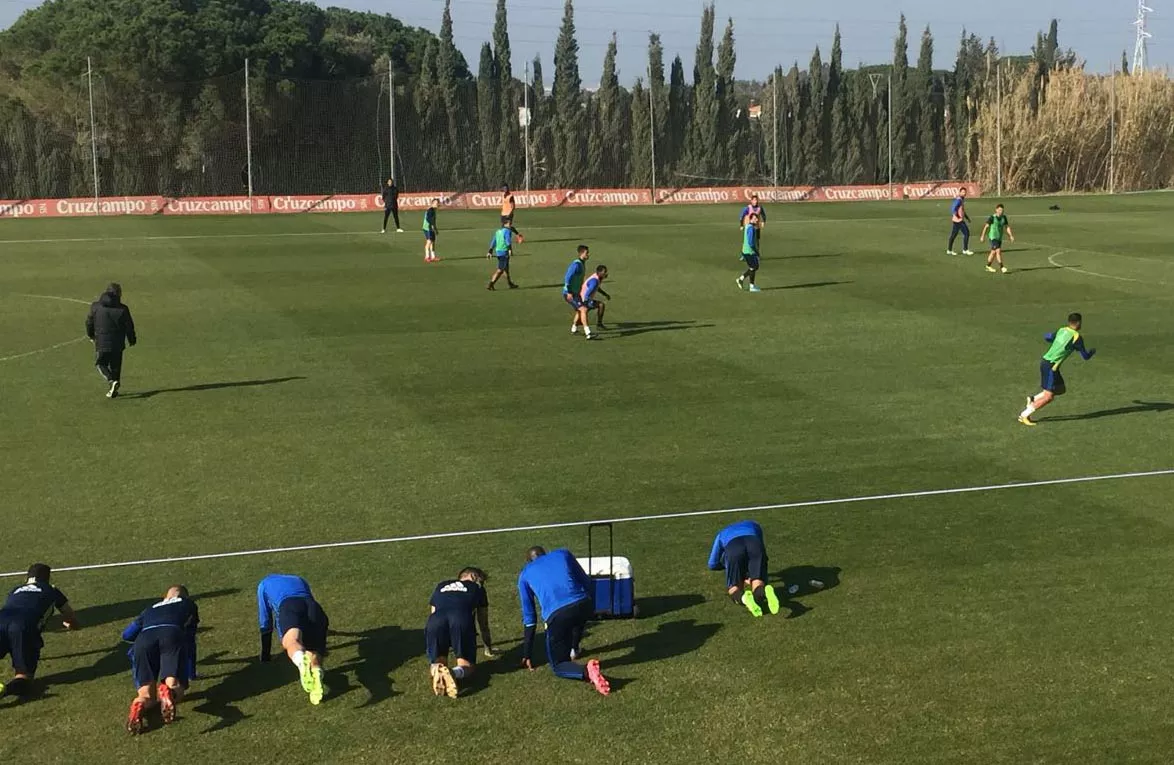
[0,195,1174,765]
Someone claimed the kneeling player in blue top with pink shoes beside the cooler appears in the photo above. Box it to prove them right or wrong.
[518,547,612,696]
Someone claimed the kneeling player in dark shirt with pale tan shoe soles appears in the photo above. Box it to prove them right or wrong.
[424,568,493,698]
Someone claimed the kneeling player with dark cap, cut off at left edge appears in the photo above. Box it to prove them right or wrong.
[0,563,77,698]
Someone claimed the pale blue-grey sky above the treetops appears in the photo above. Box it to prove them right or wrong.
[0,0,1174,86]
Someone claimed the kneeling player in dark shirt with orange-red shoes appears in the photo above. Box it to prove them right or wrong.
[122,584,200,734]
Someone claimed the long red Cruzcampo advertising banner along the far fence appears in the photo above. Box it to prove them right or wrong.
[0,181,981,219]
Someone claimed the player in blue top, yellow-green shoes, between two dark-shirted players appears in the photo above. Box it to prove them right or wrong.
[257,574,330,704]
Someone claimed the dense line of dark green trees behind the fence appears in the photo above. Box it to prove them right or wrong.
[0,0,1170,197]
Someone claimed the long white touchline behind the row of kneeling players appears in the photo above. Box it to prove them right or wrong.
[0,468,1174,576]
